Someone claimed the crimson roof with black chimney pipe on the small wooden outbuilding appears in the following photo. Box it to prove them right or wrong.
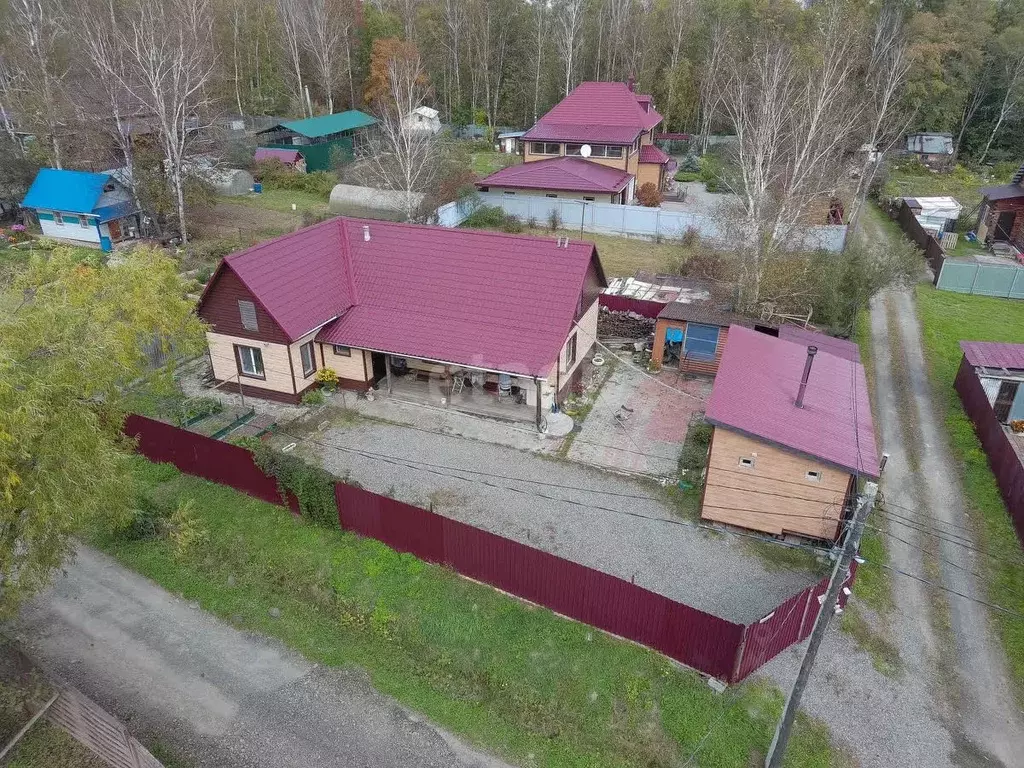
[707,326,879,477]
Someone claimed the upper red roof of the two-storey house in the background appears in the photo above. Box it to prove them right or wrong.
[523,82,662,144]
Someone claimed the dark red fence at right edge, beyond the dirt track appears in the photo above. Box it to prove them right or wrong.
[954,357,1024,545]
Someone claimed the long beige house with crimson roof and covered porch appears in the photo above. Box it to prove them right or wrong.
[198,217,606,434]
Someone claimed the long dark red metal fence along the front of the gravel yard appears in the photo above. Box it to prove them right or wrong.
[125,416,839,682]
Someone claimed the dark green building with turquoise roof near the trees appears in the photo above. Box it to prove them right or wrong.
[257,110,377,171]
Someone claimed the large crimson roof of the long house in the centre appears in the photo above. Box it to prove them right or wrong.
[199,217,604,376]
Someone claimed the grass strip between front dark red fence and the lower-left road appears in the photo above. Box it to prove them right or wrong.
[94,459,849,768]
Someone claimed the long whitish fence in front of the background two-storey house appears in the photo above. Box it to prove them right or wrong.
[437,193,846,253]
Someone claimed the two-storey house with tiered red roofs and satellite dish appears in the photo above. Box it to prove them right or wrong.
[477,80,672,204]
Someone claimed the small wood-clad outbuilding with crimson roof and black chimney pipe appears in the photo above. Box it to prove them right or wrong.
[700,326,880,541]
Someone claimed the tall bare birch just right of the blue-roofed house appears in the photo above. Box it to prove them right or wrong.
[90,0,215,243]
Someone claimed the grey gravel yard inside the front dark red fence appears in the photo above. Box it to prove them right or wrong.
[275,421,820,624]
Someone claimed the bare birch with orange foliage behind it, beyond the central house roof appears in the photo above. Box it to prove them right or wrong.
[360,40,439,221]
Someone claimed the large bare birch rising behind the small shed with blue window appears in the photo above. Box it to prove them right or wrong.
[720,2,861,311]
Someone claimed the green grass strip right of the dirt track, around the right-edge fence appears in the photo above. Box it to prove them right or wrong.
[918,286,1024,700]
